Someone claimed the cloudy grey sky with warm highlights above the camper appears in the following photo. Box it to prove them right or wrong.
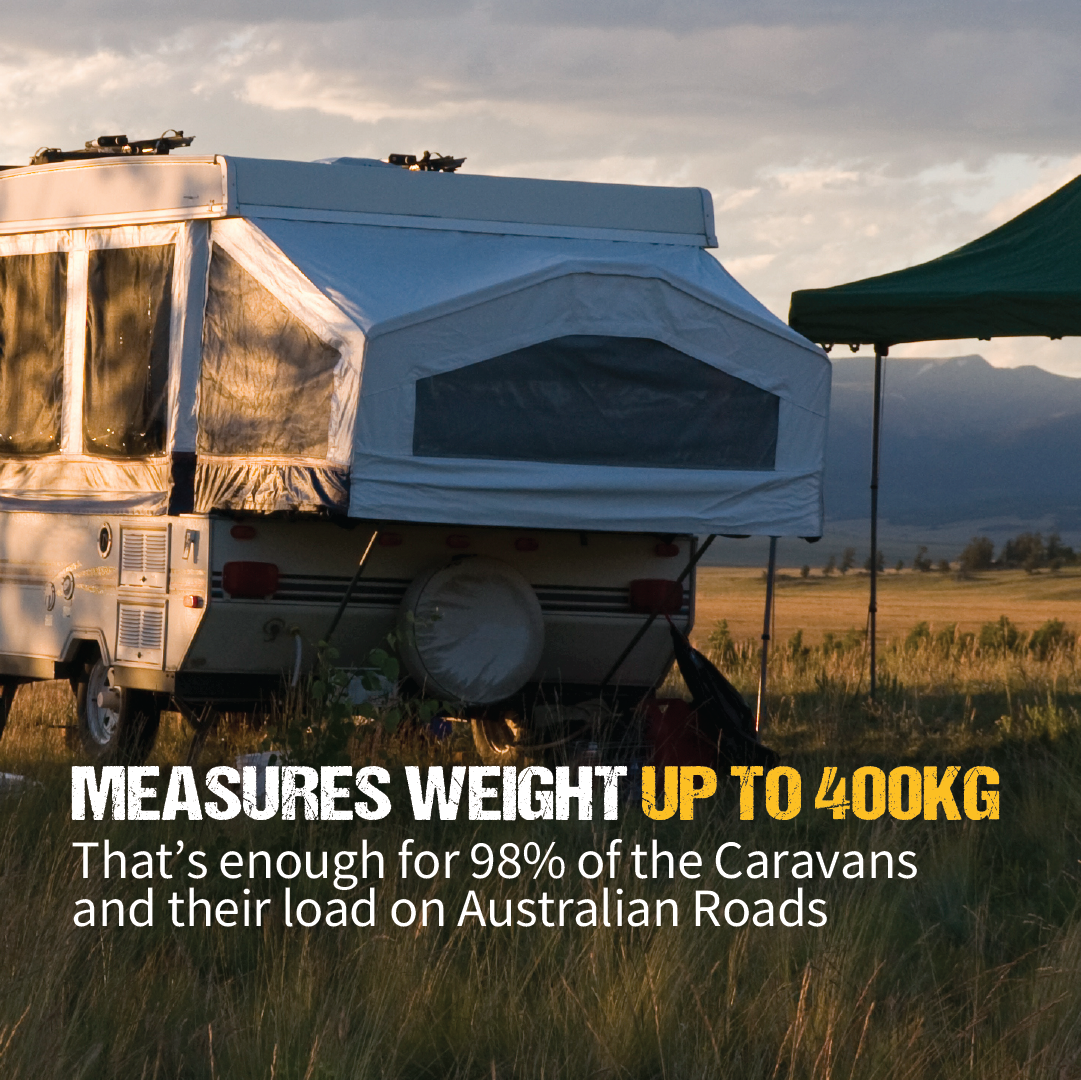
[0,0,1081,376]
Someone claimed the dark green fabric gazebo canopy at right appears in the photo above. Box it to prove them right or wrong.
[788,176,1081,347]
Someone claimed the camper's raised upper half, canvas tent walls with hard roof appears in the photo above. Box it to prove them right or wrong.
[0,157,829,535]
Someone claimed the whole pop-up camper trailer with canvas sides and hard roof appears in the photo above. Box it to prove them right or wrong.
[0,137,829,760]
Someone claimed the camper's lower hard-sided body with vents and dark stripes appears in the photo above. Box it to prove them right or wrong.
[0,510,694,760]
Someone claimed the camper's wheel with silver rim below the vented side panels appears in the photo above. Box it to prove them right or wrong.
[76,659,161,764]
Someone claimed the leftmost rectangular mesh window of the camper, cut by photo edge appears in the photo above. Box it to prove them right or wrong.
[0,252,67,455]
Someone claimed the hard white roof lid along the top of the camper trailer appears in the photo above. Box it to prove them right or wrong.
[0,156,717,248]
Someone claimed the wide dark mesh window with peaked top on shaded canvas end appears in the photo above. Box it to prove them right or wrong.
[413,336,778,469]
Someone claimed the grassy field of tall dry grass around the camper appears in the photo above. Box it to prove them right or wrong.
[0,570,1081,1080]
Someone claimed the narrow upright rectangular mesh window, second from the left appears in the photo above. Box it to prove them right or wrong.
[83,244,173,457]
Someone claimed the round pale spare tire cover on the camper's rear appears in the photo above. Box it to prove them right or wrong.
[399,557,544,705]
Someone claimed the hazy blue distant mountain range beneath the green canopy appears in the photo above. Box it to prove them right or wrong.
[826,354,1081,536]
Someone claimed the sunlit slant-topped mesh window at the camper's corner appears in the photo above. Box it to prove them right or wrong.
[199,248,341,458]
